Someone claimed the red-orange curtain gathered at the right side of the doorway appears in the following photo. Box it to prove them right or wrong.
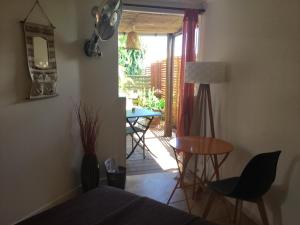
[176,9,199,137]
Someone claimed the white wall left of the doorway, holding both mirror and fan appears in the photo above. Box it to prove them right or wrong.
[0,0,125,225]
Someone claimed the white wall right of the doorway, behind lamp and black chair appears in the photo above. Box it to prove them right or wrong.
[203,0,300,225]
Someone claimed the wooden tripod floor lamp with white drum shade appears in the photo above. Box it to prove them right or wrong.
[185,62,226,138]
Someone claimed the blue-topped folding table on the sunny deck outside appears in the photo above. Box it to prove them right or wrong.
[126,108,161,159]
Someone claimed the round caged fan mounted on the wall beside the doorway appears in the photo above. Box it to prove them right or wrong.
[84,0,122,57]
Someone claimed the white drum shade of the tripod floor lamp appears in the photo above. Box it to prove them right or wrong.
[185,62,226,84]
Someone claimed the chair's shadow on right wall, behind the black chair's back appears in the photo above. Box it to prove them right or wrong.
[266,155,300,225]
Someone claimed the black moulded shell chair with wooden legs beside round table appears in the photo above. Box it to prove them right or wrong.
[203,151,281,225]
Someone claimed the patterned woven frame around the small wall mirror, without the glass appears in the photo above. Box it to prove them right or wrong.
[23,22,58,100]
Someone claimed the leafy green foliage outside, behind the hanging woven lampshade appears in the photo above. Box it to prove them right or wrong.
[118,34,145,75]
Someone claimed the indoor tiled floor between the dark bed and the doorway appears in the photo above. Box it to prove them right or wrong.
[126,172,256,225]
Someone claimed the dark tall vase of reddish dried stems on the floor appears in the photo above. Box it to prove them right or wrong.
[76,103,99,192]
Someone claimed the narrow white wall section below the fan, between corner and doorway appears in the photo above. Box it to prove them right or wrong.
[76,0,126,175]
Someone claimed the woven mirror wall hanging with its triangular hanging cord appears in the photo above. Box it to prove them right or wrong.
[21,1,57,100]
